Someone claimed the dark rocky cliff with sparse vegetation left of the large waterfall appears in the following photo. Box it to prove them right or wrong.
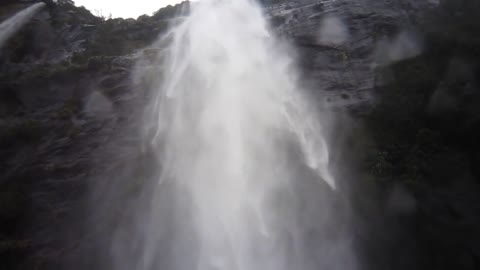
[0,1,185,269]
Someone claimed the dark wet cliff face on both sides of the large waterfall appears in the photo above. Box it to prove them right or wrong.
[0,0,480,269]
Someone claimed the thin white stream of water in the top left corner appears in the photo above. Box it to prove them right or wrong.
[0,2,45,49]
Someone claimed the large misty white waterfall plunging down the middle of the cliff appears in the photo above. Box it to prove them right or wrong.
[112,0,354,270]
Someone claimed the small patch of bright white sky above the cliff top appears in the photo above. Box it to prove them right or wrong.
[74,0,188,19]
